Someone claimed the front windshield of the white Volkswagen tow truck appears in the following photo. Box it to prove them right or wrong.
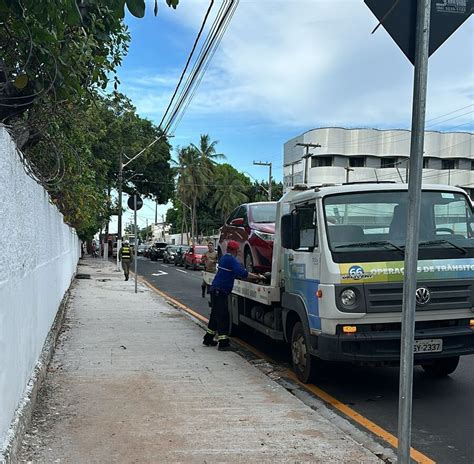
[324,191,474,263]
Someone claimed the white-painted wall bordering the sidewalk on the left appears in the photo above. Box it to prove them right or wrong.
[0,125,79,448]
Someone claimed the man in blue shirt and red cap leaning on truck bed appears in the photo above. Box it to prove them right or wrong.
[202,240,262,351]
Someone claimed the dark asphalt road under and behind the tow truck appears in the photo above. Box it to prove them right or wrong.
[138,258,474,464]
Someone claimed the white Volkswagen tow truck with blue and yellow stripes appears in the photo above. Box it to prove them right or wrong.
[204,183,474,382]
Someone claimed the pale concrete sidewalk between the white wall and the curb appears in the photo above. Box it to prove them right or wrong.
[19,259,381,463]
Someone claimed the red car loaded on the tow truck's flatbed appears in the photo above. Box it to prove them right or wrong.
[217,201,277,272]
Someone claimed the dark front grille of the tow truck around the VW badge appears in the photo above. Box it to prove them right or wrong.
[364,280,474,313]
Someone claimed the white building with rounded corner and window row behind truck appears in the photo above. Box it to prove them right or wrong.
[283,127,474,198]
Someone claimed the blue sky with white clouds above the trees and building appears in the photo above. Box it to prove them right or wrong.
[111,0,474,229]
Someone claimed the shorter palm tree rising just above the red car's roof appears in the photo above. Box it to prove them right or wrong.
[214,166,248,220]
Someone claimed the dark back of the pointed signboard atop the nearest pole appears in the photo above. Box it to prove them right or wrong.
[364,0,474,64]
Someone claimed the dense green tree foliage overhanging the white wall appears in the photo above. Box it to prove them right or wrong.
[0,0,178,238]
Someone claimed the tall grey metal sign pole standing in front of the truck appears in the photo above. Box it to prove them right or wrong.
[398,0,431,464]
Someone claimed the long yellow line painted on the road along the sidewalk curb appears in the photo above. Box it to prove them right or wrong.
[141,276,436,464]
